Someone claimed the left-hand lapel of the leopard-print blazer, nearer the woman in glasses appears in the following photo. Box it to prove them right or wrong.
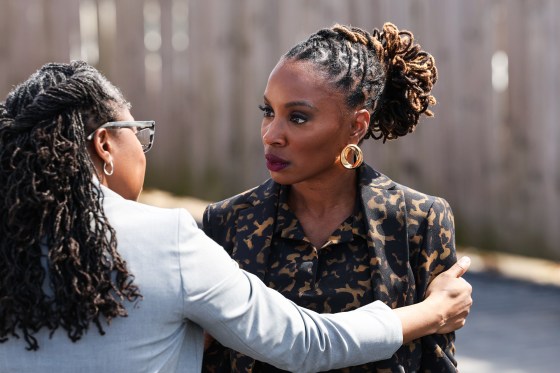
[231,180,280,280]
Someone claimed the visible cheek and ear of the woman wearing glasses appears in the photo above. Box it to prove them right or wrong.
[90,108,146,201]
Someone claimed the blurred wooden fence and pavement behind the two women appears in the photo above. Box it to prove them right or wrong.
[0,0,560,372]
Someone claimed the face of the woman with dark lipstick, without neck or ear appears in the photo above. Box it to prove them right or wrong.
[261,61,358,185]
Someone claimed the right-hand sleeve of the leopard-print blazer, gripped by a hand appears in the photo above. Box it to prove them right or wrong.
[415,197,458,373]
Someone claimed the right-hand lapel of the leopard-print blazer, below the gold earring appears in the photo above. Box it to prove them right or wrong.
[360,166,411,308]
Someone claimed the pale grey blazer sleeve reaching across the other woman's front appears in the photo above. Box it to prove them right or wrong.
[178,210,402,372]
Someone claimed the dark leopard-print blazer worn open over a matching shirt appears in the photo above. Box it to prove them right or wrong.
[203,165,457,373]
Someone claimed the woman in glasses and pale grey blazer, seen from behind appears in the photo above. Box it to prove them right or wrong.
[0,62,471,373]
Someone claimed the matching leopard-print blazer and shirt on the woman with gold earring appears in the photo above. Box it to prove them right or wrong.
[203,165,458,373]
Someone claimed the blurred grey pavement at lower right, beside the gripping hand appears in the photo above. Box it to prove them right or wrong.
[456,271,560,373]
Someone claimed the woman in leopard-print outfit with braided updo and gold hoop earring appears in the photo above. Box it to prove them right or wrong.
[203,23,466,373]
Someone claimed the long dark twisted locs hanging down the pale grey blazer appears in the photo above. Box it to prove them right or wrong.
[0,62,141,350]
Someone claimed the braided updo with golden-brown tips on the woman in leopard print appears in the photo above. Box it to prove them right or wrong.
[283,23,437,142]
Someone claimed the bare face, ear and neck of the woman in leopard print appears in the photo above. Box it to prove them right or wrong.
[261,60,369,247]
